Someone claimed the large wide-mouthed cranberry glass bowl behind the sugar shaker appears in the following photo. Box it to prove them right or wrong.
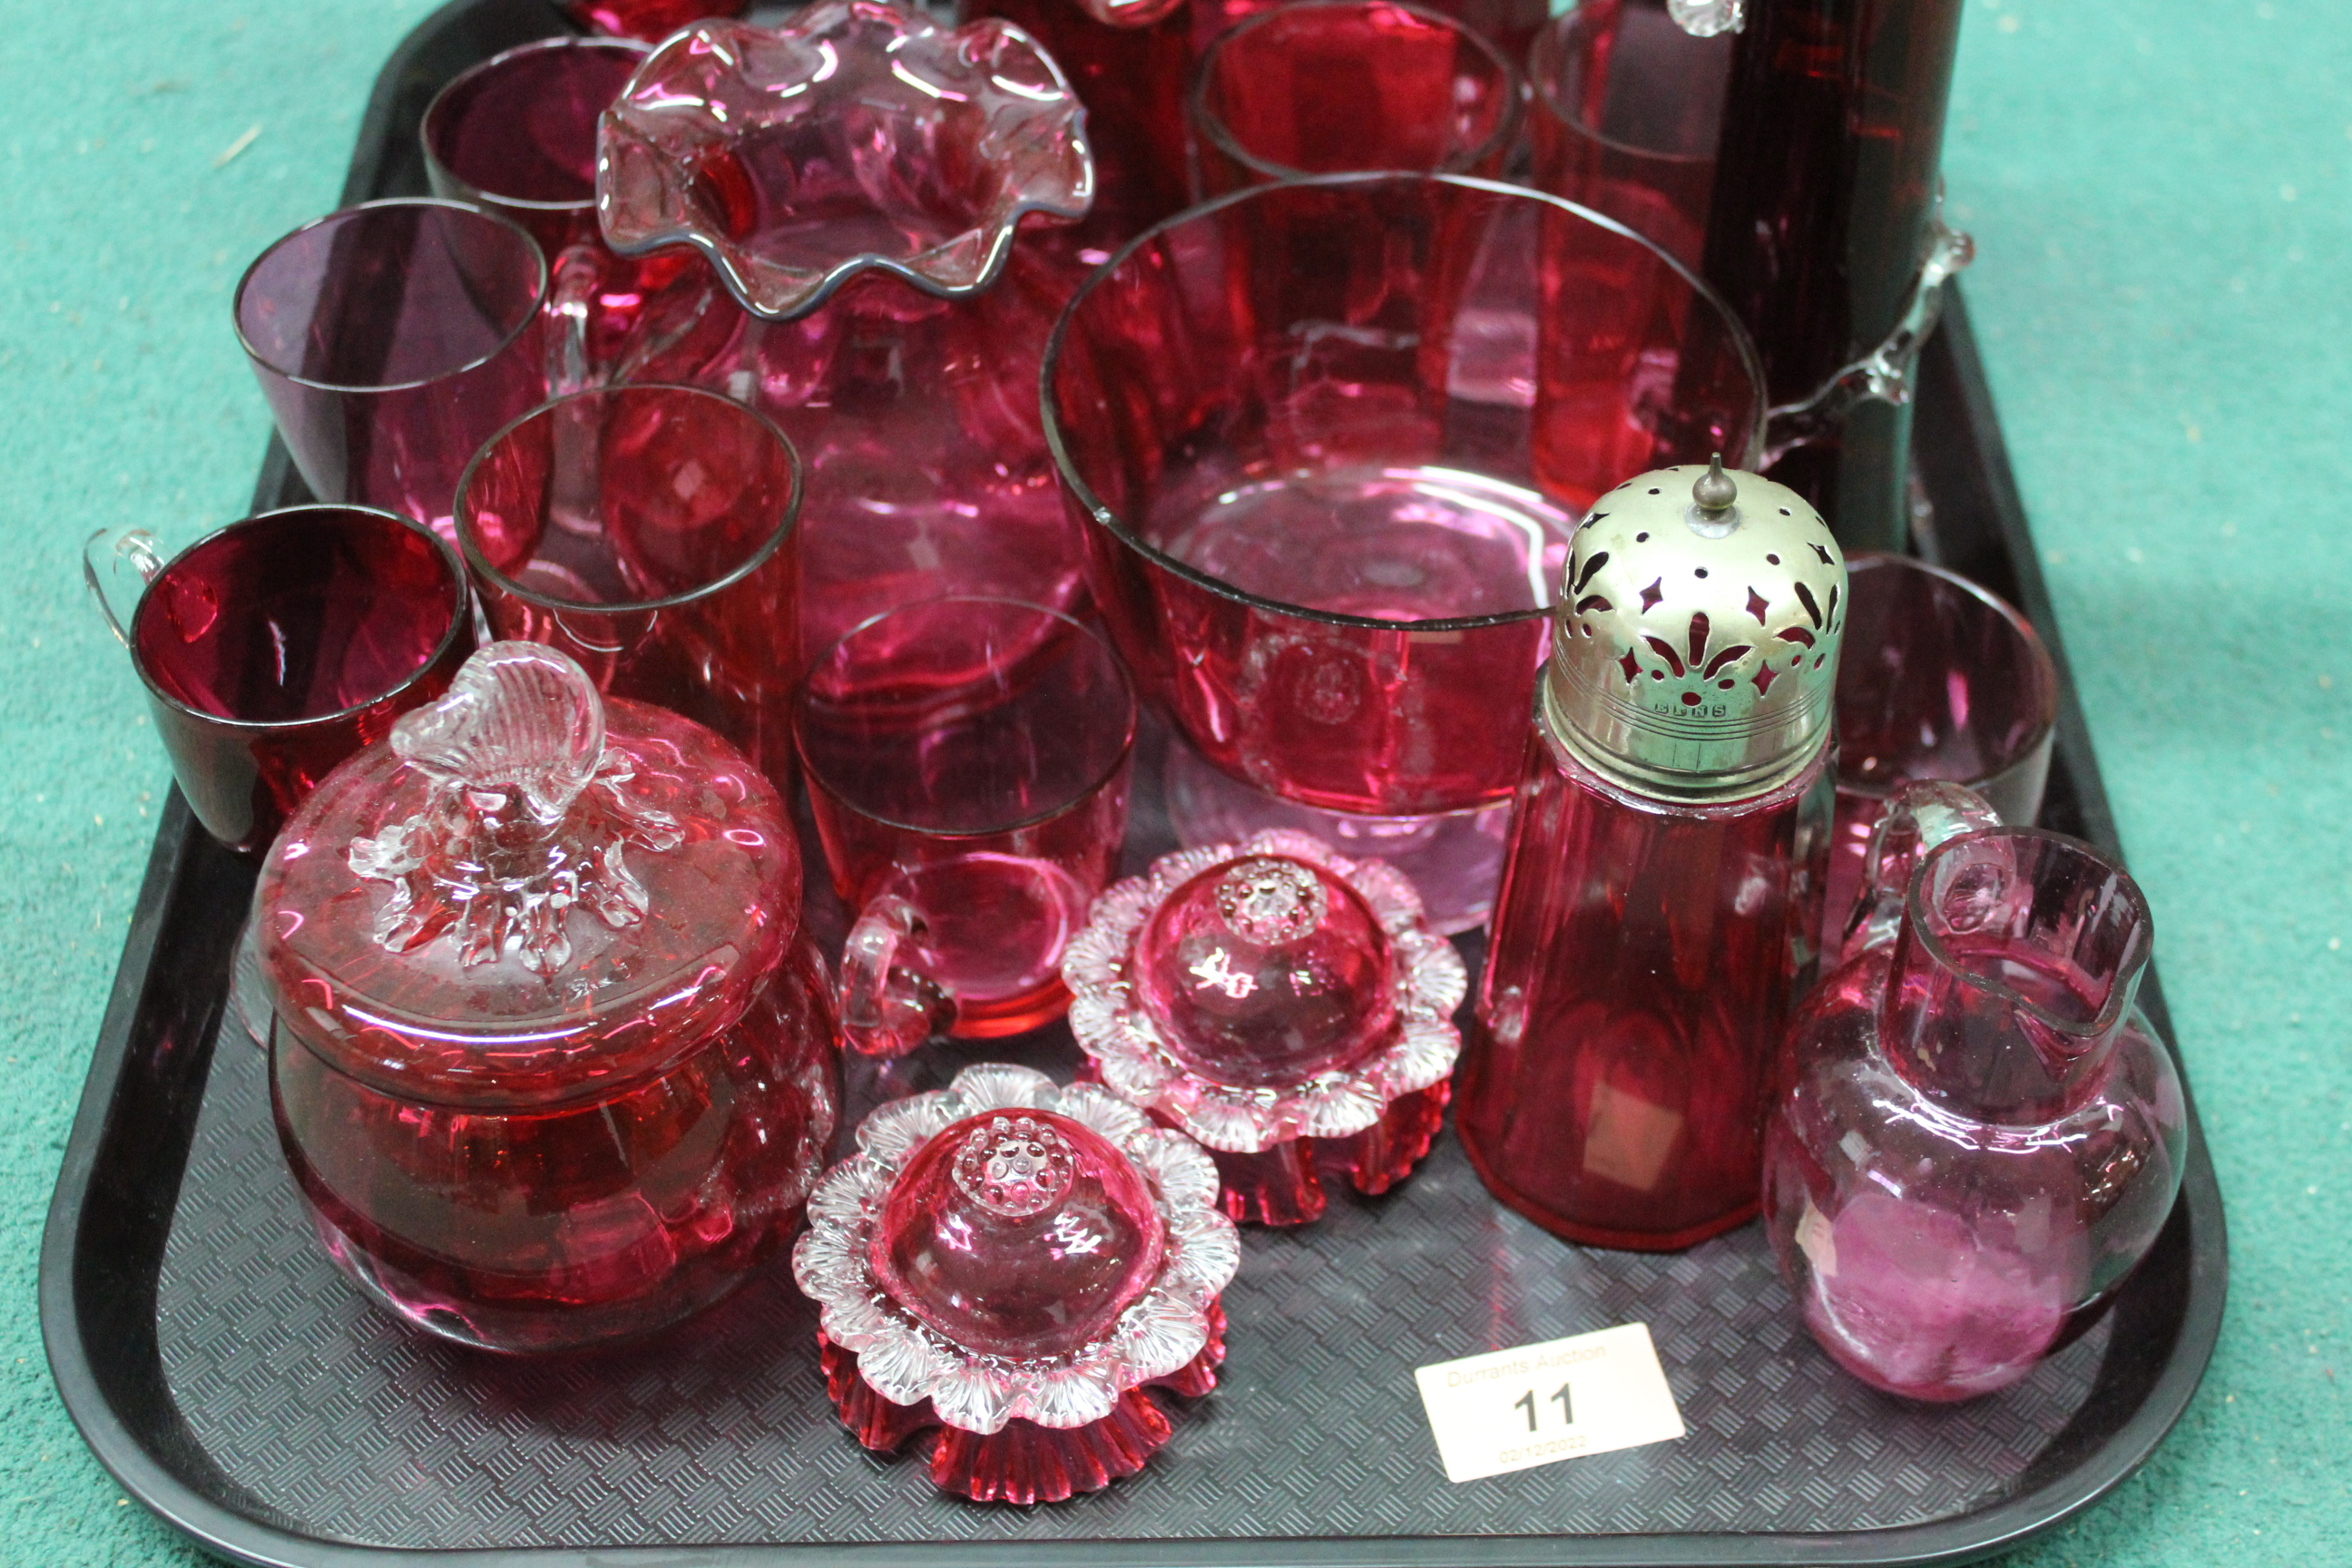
[1044,174,1761,816]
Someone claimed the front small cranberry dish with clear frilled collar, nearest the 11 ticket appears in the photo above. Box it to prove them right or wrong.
[793,1063,1242,1502]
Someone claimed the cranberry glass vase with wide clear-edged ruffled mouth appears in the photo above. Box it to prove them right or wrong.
[597,0,1093,653]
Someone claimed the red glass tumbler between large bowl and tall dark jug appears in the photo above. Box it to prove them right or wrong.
[1526,0,1733,268]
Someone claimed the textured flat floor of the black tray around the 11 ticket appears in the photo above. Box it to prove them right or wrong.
[158,1039,2107,1547]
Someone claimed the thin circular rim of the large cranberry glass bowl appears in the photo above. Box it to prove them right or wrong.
[1037,172,1769,632]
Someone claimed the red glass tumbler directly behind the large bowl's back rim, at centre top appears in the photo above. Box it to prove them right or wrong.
[1191,0,1519,195]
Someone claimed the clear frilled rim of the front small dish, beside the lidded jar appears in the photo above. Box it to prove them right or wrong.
[793,1063,1242,1436]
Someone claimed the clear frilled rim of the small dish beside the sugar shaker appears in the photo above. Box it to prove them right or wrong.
[1061,828,1470,1154]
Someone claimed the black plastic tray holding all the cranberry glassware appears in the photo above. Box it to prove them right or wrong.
[40,0,2225,1568]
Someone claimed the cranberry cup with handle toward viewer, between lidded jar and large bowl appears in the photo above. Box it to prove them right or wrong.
[798,597,1136,1055]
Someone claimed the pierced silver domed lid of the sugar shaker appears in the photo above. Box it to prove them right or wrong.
[1541,458,1847,801]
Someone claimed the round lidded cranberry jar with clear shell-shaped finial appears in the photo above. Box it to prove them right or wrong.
[257,642,838,1352]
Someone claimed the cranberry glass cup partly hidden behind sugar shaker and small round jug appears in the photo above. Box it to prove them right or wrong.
[1820,554,2058,955]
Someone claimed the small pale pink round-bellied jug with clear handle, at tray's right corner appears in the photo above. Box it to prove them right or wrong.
[1764,785,2188,1401]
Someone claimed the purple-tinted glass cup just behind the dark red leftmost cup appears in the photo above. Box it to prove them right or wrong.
[235,198,548,538]
